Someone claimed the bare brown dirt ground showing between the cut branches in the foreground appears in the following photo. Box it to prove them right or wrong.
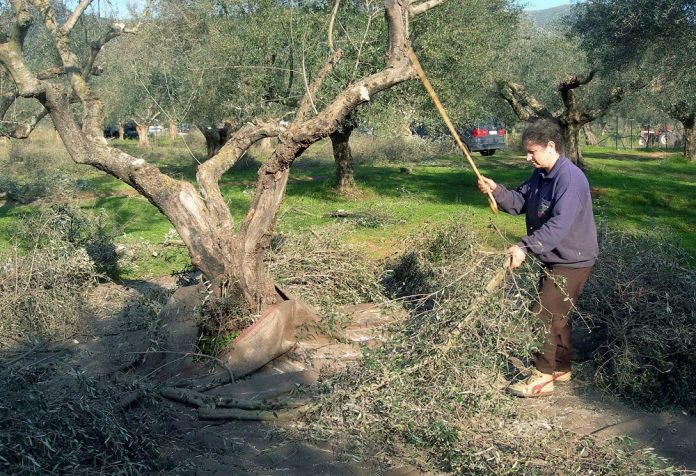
[4,278,696,476]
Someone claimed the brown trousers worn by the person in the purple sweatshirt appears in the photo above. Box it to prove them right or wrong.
[532,266,592,374]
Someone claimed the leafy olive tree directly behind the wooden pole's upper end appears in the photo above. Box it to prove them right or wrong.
[331,0,520,189]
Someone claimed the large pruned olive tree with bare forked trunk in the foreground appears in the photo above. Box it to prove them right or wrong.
[0,0,440,356]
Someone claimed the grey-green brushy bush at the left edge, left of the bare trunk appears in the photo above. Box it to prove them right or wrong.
[0,205,115,341]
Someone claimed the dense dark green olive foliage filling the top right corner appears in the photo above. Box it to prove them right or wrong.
[572,0,696,161]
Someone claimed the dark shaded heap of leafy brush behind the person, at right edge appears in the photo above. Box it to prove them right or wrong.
[580,230,696,413]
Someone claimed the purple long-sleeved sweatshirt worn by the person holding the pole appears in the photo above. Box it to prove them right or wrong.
[493,156,599,268]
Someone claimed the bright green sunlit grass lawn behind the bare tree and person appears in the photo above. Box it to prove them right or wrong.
[0,138,696,278]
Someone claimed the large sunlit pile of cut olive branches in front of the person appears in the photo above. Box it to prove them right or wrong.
[296,218,676,474]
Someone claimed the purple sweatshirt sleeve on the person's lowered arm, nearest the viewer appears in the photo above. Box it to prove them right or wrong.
[518,178,581,256]
